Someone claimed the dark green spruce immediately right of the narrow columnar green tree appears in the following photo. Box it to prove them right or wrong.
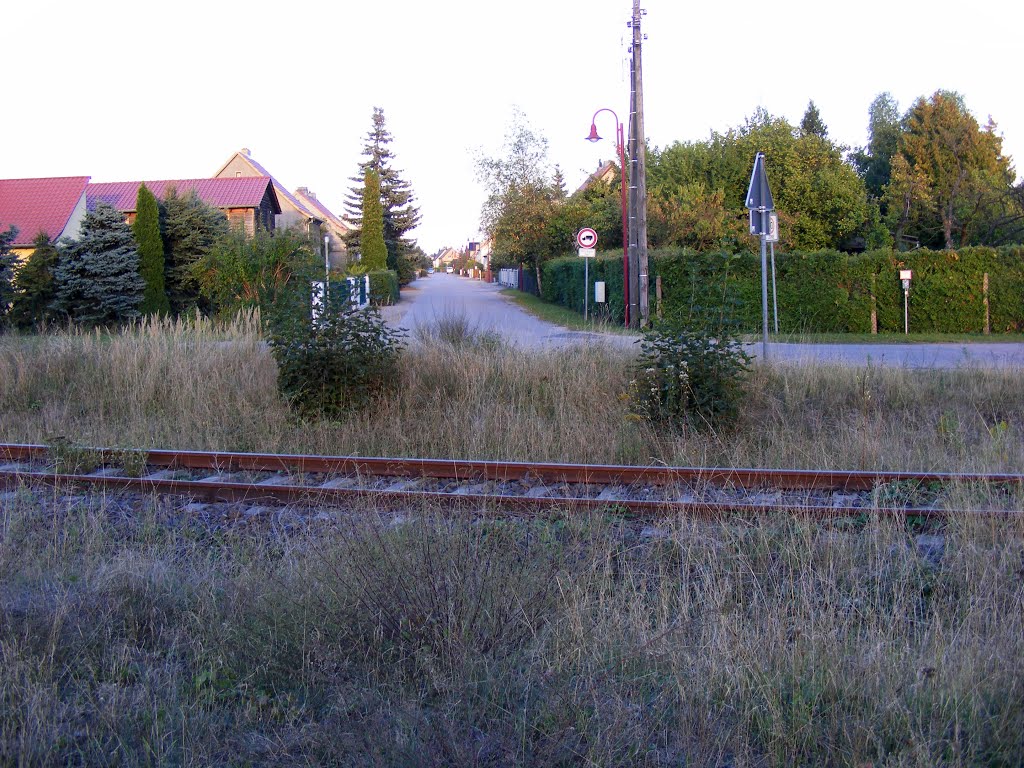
[163,189,227,314]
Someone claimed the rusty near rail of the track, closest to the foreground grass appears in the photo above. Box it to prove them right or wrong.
[0,470,966,518]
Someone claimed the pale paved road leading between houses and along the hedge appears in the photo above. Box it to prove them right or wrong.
[384,273,1024,369]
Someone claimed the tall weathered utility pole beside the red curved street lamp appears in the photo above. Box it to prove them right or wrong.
[629,0,650,328]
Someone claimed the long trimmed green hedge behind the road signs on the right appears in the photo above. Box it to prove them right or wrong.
[542,246,1024,333]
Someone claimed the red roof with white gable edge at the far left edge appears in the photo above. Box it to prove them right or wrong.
[0,176,89,246]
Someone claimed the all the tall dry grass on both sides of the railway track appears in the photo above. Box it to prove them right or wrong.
[0,319,1024,768]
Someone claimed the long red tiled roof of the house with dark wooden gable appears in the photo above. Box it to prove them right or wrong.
[85,176,281,213]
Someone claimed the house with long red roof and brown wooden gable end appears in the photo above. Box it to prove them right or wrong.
[85,176,281,234]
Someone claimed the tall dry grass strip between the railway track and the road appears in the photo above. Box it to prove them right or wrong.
[0,317,1024,472]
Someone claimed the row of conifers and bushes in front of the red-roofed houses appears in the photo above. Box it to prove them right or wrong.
[0,184,318,330]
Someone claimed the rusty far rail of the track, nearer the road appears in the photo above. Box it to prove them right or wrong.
[0,443,1024,490]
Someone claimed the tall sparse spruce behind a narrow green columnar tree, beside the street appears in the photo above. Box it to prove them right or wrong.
[345,106,420,271]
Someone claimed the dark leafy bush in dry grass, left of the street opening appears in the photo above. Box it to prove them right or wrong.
[270,302,402,417]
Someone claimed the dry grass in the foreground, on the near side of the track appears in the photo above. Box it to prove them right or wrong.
[0,490,1024,767]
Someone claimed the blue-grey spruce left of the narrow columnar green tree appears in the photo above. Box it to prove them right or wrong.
[53,203,145,326]
